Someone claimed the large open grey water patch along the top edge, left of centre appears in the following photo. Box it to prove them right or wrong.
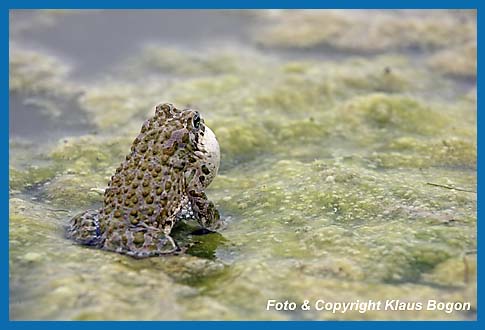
[11,10,255,79]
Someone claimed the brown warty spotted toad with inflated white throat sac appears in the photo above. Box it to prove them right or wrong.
[67,103,219,258]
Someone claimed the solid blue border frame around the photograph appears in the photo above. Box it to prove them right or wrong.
[0,0,485,329]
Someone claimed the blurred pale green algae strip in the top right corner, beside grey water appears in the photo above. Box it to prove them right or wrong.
[254,10,476,52]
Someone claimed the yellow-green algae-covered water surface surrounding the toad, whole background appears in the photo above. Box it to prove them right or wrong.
[9,10,477,320]
